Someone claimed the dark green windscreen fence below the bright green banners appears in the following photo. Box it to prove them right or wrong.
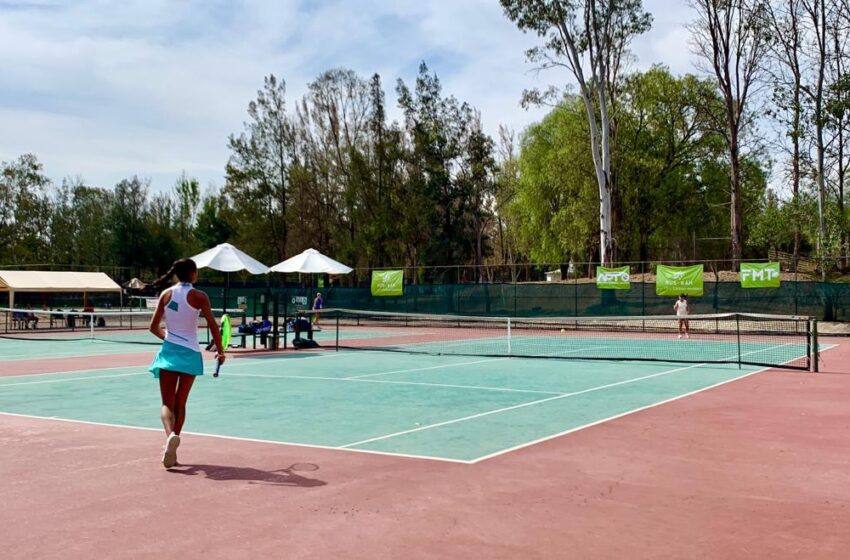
[200,281,850,321]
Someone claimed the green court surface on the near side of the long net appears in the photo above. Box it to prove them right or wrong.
[0,341,780,462]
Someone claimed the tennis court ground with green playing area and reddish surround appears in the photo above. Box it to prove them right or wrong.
[0,312,850,558]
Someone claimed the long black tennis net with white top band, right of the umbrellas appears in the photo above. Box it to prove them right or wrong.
[292,309,817,371]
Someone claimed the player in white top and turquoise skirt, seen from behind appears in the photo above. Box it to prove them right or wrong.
[150,259,224,469]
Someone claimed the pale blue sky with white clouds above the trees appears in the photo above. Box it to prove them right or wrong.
[0,0,696,191]
